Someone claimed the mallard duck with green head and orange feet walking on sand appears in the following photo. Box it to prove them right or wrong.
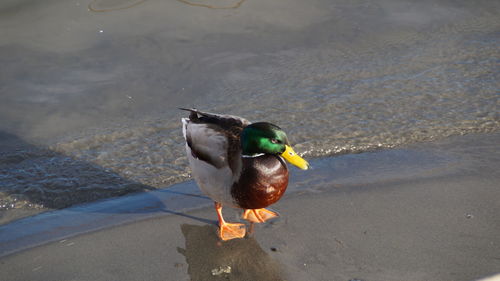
[181,108,309,241]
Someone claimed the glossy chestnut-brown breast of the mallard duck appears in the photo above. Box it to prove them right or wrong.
[231,154,288,209]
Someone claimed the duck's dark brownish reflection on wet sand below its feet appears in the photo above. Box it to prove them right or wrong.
[177,224,283,281]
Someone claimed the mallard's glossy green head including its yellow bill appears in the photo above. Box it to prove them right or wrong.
[241,122,309,170]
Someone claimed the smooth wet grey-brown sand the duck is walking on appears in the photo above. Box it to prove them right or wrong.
[0,133,500,281]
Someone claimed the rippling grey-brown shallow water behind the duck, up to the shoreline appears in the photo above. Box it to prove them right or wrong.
[0,0,500,220]
